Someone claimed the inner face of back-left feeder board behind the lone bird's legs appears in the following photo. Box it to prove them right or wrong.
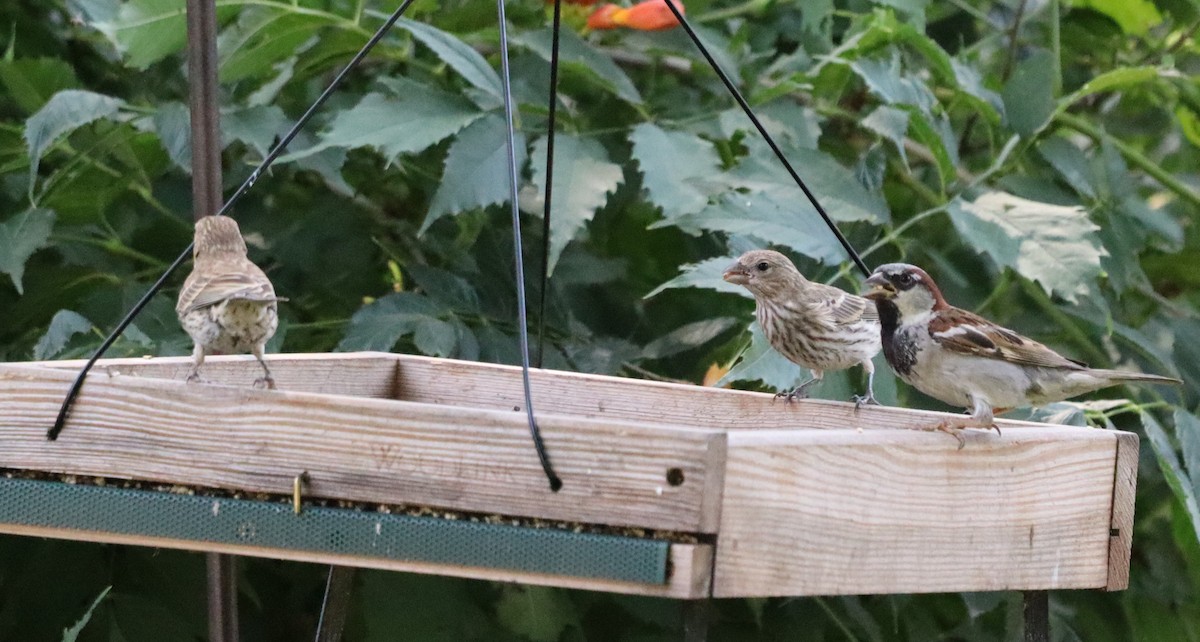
[31,353,396,398]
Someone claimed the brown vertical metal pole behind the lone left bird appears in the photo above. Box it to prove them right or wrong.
[187,0,238,642]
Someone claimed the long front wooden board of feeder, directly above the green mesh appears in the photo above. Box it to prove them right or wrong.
[0,360,725,533]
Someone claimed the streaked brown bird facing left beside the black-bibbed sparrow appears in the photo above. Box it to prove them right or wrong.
[724,250,880,404]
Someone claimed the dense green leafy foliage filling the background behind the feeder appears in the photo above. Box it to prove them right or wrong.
[0,0,1200,641]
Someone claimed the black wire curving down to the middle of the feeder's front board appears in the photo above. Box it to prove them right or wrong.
[496,0,563,492]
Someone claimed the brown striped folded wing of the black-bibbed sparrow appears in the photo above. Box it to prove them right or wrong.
[929,307,1086,370]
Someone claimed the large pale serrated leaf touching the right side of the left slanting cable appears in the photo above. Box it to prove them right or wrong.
[300,78,484,162]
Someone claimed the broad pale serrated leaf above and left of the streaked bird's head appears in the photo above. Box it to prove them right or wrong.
[629,122,721,218]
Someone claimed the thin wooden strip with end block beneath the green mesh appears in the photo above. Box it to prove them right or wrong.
[0,524,713,599]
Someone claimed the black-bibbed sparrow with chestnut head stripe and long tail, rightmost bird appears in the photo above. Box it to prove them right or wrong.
[865,263,1183,448]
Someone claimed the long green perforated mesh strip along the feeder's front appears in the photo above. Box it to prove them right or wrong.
[0,479,670,583]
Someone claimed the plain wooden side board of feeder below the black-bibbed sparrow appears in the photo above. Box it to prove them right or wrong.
[714,426,1116,598]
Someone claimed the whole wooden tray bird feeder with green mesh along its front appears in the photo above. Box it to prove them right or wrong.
[0,353,1138,599]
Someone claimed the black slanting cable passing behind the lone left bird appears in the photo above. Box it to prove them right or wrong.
[46,0,422,442]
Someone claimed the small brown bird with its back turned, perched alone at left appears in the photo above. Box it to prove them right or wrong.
[175,216,286,388]
